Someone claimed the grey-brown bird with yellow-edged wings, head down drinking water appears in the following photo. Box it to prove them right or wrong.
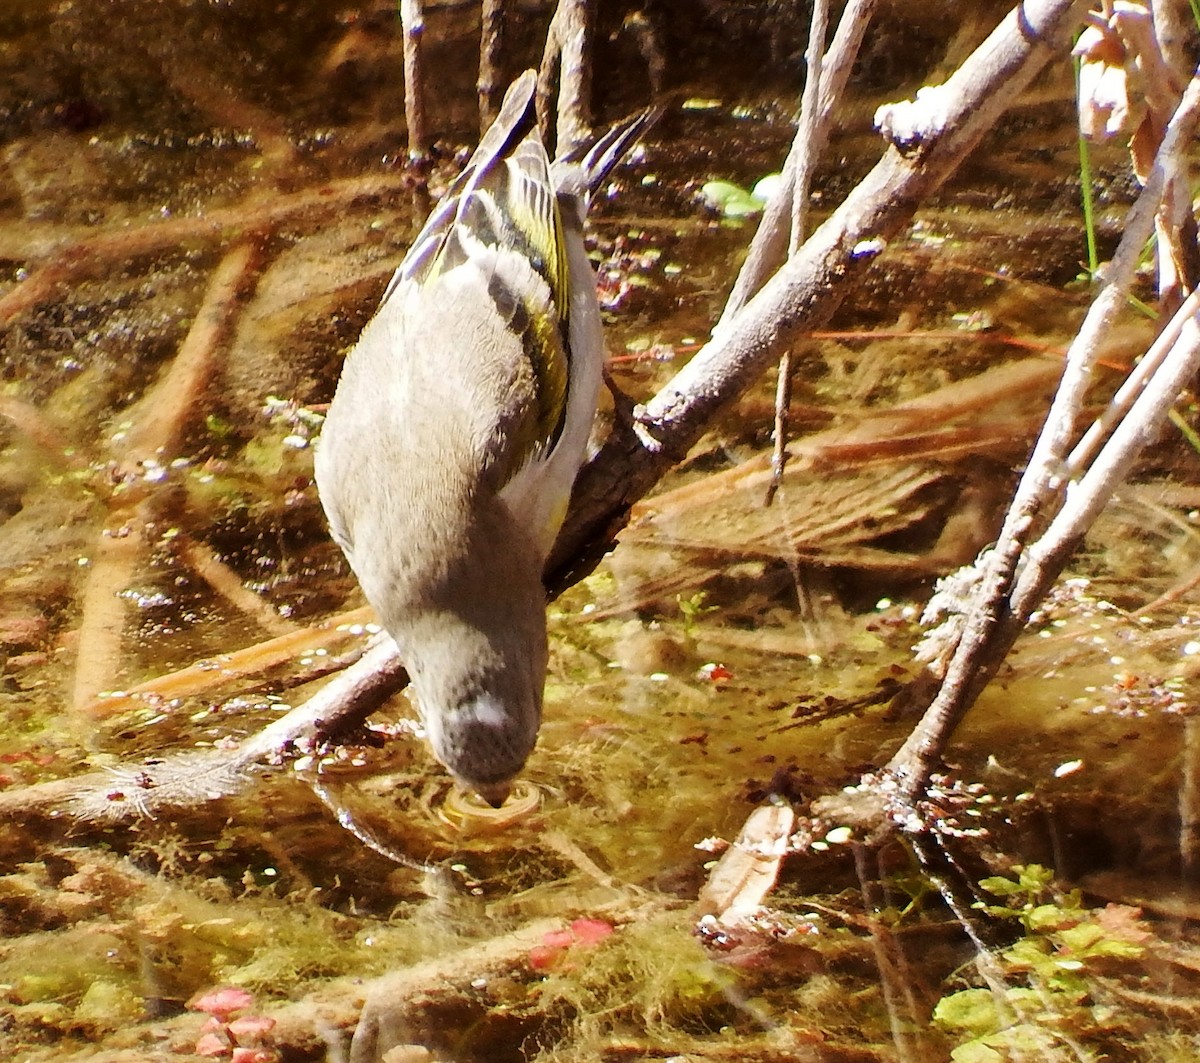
[314,71,649,807]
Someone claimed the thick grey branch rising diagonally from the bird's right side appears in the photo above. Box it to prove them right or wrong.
[547,0,1085,587]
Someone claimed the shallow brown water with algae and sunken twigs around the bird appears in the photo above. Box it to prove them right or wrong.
[0,2,1200,1063]
